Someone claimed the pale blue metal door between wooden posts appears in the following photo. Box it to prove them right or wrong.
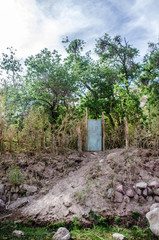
[87,119,102,151]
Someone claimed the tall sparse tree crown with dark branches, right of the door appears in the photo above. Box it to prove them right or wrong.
[95,34,139,91]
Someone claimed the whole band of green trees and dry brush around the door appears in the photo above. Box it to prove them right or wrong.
[0,34,159,152]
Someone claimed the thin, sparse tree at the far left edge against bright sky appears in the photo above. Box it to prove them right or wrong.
[0,47,25,122]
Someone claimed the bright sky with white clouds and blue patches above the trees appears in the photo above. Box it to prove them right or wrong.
[0,0,159,58]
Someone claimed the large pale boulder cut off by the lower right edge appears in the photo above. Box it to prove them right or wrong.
[146,208,159,236]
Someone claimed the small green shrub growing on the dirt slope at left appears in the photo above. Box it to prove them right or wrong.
[6,164,27,185]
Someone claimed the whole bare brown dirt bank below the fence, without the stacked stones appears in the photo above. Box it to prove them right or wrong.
[1,148,159,223]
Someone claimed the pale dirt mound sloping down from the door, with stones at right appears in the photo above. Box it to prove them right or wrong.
[13,148,159,222]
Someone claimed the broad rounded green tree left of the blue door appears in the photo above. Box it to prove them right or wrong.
[25,48,77,123]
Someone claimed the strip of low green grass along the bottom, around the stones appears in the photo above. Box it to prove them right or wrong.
[0,220,158,240]
